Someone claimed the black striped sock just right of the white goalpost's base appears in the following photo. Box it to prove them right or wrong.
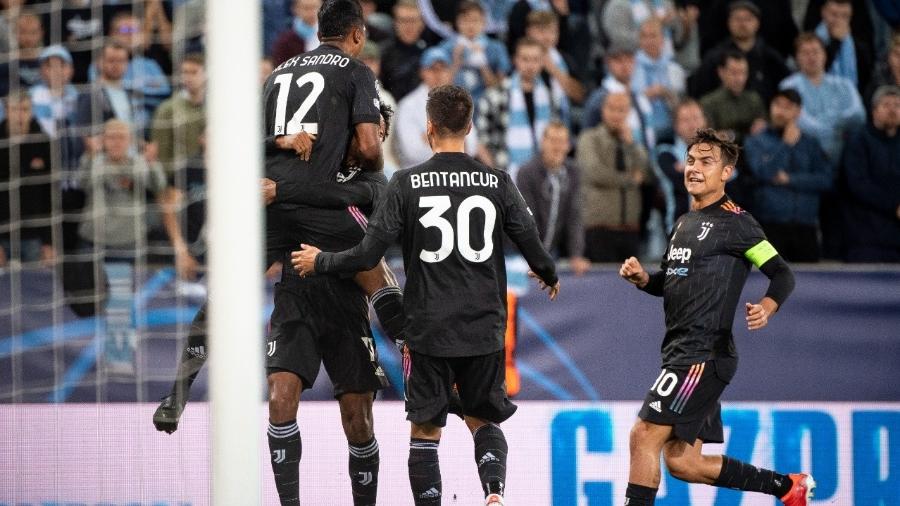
[269,420,303,506]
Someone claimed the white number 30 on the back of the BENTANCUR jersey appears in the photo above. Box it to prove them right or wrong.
[419,195,497,263]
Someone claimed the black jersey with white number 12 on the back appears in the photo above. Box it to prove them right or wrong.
[263,44,381,190]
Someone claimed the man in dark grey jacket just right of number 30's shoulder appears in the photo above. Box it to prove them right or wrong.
[516,121,591,276]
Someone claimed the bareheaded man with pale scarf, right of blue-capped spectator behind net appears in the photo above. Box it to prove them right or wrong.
[75,41,148,144]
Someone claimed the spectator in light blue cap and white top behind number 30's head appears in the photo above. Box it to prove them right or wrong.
[390,47,478,169]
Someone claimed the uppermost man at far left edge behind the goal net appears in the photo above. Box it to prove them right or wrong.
[0,12,44,96]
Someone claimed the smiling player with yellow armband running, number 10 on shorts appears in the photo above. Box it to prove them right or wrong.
[619,130,816,506]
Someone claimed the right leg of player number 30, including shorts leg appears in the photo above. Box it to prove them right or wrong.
[450,350,516,505]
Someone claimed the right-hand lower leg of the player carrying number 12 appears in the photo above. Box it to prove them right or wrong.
[338,392,380,506]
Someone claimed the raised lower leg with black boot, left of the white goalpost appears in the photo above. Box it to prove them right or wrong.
[153,303,207,434]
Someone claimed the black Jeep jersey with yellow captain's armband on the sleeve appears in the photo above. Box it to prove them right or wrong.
[662,196,778,367]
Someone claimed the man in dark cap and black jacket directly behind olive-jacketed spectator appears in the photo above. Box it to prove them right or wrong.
[688,0,788,102]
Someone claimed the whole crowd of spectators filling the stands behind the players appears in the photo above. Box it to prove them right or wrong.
[0,0,900,279]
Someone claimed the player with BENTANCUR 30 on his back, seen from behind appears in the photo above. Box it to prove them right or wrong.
[292,86,559,505]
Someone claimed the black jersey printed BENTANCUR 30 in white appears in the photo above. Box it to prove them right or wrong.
[368,153,556,357]
